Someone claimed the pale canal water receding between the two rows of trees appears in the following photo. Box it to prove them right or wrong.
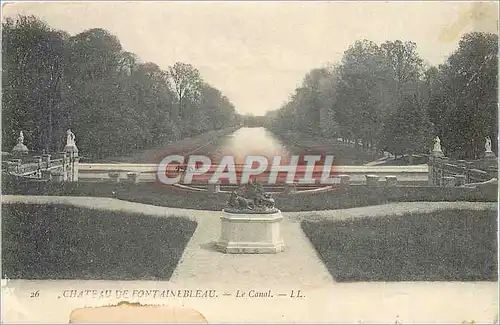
[211,127,290,164]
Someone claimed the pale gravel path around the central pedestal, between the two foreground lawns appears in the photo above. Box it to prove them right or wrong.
[170,215,333,287]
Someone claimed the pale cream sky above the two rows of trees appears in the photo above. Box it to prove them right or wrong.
[3,1,498,115]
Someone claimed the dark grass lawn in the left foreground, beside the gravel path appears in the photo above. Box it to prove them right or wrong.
[2,204,197,280]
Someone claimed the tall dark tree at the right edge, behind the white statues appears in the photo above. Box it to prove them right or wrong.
[429,32,498,159]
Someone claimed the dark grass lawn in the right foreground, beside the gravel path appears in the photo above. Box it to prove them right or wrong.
[302,210,498,282]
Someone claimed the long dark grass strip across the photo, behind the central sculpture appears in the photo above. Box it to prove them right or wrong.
[2,176,498,212]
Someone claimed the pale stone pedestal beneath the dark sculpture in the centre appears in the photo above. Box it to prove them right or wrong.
[216,210,285,254]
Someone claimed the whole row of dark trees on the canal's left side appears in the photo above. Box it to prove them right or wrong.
[2,16,239,157]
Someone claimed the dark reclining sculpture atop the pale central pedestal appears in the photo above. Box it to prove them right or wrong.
[224,181,278,213]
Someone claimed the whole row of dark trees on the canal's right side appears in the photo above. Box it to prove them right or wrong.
[267,32,498,159]
